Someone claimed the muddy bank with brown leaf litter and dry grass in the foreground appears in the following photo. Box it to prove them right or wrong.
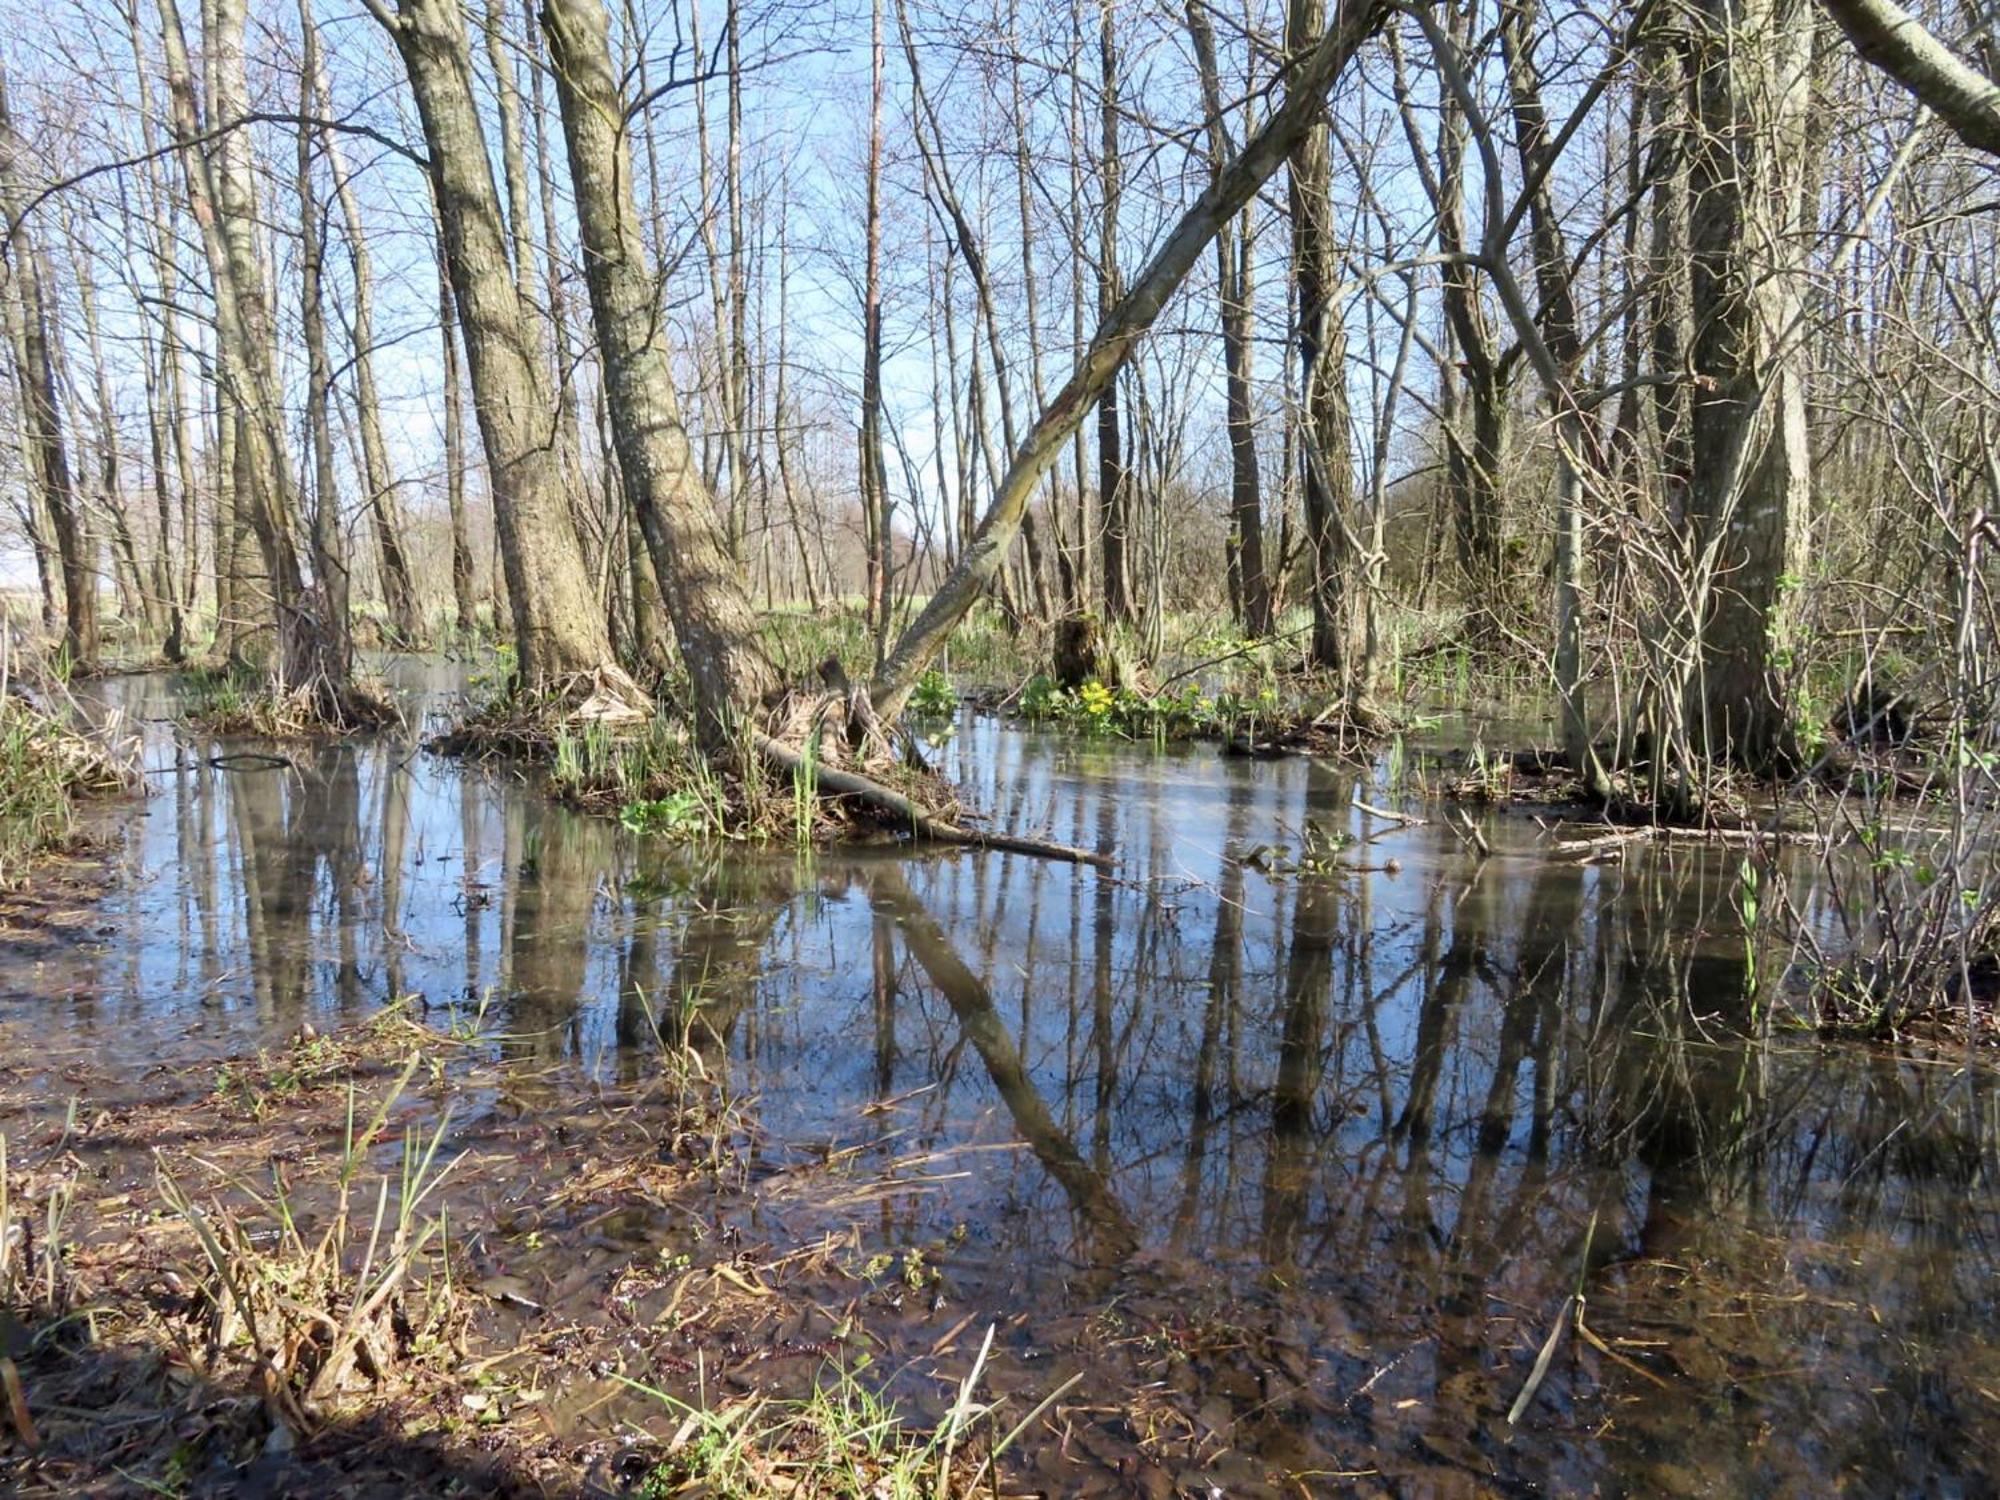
[0,1008,1096,1496]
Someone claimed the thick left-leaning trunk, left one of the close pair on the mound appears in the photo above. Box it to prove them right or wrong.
[370,0,636,692]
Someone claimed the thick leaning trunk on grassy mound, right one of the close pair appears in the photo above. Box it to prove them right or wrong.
[542,0,778,756]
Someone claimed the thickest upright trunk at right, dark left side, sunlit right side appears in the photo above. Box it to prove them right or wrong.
[1688,0,1812,768]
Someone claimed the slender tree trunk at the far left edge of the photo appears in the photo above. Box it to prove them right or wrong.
[0,78,98,666]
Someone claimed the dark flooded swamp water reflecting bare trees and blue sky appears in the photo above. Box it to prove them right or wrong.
[11,664,2000,1496]
